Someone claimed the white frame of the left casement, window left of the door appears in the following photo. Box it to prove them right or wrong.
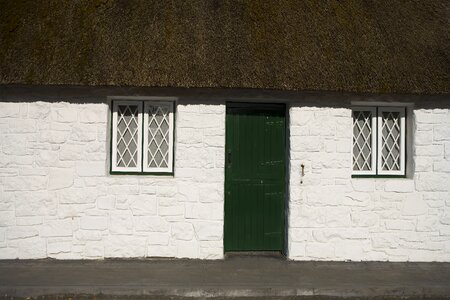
[111,101,142,172]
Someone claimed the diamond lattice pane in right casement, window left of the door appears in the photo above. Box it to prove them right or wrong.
[147,104,171,168]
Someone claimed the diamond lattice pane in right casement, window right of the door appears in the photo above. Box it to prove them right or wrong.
[381,111,401,171]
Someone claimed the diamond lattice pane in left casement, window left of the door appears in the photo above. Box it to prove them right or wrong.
[116,105,139,168]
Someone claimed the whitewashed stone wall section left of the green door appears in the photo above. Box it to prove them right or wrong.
[0,102,225,259]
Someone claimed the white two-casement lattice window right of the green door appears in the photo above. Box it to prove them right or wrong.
[352,107,406,175]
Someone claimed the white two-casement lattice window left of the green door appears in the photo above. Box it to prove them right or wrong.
[111,101,174,173]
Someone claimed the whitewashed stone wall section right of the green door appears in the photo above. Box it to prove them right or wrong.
[288,105,450,261]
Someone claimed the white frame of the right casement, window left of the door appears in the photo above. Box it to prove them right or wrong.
[142,101,175,173]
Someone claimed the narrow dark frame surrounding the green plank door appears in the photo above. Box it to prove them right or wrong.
[222,101,290,257]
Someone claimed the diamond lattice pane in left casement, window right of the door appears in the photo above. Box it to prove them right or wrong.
[353,111,374,171]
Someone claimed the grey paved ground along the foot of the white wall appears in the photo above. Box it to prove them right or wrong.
[0,257,450,299]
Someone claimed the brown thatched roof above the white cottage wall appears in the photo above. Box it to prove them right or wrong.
[0,0,450,94]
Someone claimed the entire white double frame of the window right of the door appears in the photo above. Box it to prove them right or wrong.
[351,105,407,176]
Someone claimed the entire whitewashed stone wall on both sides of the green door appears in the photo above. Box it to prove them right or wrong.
[0,101,450,261]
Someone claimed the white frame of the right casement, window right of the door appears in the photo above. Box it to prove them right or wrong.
[377,106,406,175]
